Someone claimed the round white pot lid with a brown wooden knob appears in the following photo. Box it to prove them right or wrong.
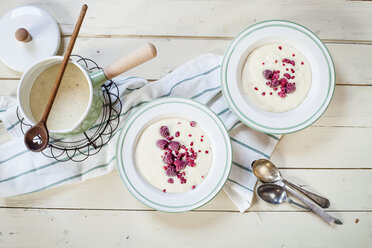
[0,6,60,72]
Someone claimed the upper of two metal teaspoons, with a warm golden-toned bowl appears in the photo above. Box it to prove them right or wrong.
[252,159,330,208]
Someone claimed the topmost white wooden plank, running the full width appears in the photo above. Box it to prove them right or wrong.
[0,0,372,41]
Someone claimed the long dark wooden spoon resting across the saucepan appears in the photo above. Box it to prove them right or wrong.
[24,4,88,152]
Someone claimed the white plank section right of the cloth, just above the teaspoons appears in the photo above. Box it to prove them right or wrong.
[271,127,372,168]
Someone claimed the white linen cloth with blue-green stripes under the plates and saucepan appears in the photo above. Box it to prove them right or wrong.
[0,54,280,212]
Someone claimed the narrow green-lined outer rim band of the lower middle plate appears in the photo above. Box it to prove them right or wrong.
[116,97,232,213]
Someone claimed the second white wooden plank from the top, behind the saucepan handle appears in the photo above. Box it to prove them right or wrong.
[0,38,372,85]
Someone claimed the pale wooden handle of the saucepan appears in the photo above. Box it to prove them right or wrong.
[103,43,157,79]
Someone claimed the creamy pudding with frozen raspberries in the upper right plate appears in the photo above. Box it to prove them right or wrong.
[242,43,312,112]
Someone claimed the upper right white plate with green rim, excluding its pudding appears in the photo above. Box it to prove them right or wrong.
[221,20,335,134]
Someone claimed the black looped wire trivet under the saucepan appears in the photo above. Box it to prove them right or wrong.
[17,55,122,162]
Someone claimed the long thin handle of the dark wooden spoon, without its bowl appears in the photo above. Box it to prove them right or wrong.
[41,4,88,123]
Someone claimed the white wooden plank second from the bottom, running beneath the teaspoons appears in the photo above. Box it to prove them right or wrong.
[0,169,372,212]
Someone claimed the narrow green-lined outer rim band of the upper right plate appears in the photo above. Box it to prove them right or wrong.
[220,20,336,134]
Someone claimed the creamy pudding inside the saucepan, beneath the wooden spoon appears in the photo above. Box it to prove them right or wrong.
[29,63,90,130]
